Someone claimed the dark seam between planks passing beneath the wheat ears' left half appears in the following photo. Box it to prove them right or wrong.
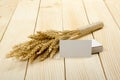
[24,0,41,80]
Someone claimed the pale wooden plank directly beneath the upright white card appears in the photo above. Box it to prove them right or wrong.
[63,0,105,80]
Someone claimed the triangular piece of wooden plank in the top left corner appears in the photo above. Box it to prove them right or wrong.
[0,0,19,41]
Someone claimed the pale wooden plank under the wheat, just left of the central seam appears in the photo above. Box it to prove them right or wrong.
[26,0,64,80]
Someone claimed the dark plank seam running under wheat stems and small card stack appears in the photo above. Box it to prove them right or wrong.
[82,0,108,80]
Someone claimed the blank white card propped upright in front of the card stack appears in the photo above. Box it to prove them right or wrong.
[60,40,92,58]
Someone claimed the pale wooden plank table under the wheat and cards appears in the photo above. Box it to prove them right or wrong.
[0,0,120,80]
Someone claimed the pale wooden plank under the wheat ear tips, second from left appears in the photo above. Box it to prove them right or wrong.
[0,0,39,80]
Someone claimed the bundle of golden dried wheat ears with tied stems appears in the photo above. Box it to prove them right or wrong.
[7,22,103,62]
